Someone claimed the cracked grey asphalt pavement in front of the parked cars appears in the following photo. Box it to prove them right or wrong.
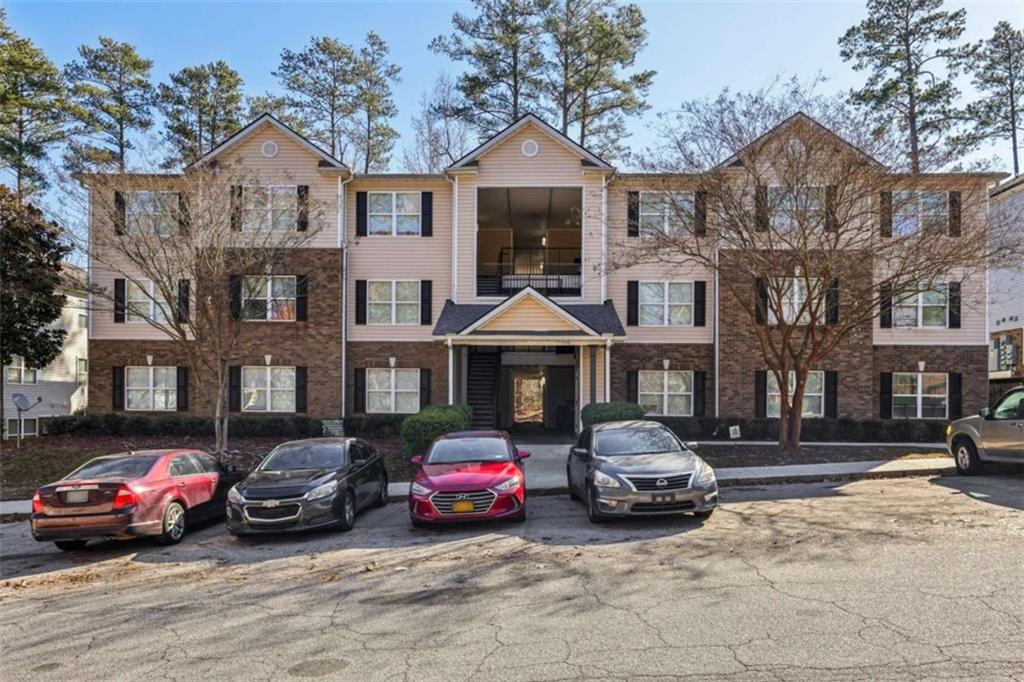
[0,470,1024,682]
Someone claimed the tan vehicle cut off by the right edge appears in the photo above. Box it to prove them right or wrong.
[946,387,1024,476]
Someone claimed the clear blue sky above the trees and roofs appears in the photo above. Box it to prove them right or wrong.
[3,0,1024,167]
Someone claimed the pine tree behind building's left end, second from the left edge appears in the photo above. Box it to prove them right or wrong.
[65,36,156,173]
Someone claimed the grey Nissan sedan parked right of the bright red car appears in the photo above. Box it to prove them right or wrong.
[565,421,718,523]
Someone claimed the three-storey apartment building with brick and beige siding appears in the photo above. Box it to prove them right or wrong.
[81,115,997,431]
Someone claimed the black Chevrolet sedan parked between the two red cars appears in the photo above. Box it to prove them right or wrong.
[227,438,387,536]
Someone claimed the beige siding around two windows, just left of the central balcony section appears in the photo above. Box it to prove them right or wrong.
[345,176,452,341]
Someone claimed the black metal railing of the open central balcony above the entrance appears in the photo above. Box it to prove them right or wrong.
[476,247,583,296]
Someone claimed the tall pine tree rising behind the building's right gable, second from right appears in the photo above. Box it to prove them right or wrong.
[839,0,969,173]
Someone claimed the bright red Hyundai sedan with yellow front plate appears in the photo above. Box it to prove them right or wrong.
[409,431,529,526]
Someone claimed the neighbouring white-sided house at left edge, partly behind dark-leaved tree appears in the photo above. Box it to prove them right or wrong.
[3,265,89,438]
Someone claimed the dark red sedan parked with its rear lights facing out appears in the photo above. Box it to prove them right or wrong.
[31,450,241,550]
